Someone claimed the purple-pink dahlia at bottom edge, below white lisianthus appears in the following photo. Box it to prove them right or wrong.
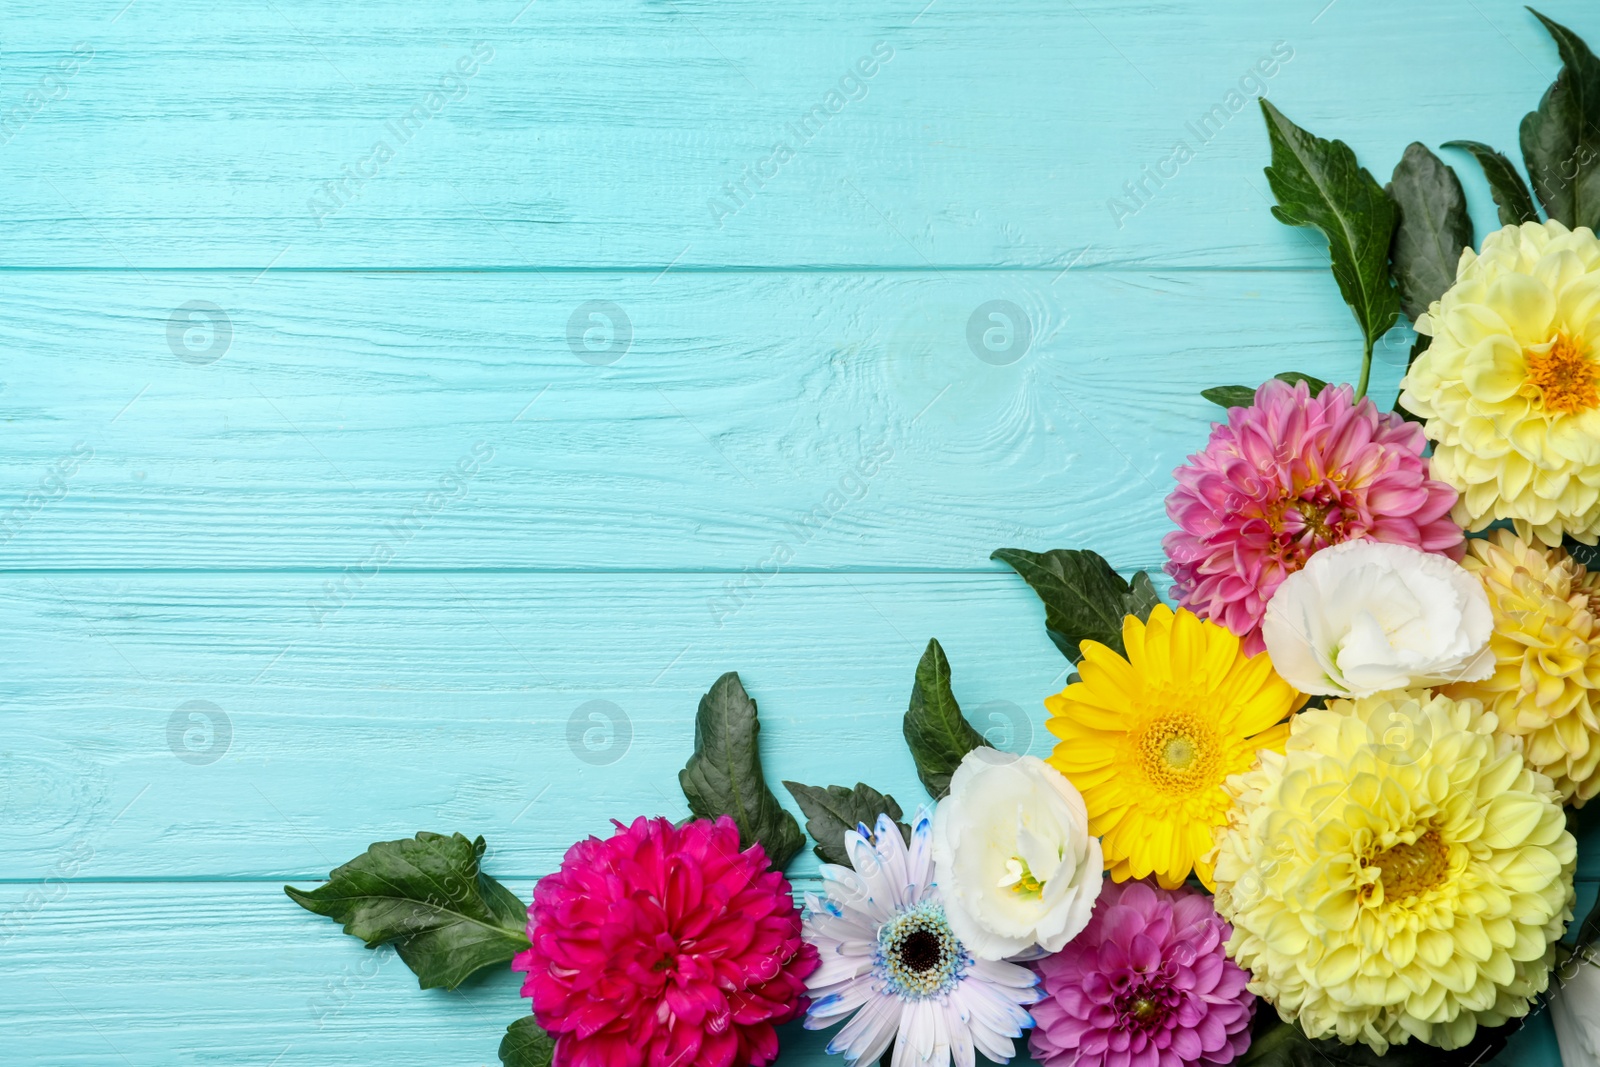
[1029,881,1256,1067]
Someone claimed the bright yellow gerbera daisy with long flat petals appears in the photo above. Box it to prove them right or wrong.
[1045,605,1306,889]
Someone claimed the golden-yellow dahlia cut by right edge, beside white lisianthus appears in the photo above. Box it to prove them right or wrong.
[1442,530,1600,806]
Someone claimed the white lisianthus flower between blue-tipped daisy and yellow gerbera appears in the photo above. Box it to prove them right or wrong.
[933,749,1104,960]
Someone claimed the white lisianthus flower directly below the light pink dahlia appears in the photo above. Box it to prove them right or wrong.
[1261,541,1494,697]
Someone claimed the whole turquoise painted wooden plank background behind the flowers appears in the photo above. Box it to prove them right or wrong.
[0,0,1600,1067]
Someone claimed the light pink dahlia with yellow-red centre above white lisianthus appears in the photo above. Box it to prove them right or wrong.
[1162,379,1462,656]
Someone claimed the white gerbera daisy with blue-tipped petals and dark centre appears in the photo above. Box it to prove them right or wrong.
[805,808,1040,1067]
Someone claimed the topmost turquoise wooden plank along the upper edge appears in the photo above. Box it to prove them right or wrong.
[0,0,1580,270]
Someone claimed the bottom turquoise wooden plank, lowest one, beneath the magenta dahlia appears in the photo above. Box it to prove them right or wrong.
[0,883,1574,1067]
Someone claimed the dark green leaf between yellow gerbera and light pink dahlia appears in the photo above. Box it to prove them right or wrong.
[989,549,1162,662]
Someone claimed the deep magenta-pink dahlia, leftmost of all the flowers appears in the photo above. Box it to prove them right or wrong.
[512,817,818,1067]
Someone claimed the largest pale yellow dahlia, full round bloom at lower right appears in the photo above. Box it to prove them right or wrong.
[1216,689,1578,1053]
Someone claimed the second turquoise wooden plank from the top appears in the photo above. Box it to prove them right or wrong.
[0,270,1410,584]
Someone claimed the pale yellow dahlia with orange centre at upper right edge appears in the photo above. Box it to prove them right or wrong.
[1400,221,1600,545]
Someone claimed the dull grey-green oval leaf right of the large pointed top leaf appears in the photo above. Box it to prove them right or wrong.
[1387,141,1472,320]
